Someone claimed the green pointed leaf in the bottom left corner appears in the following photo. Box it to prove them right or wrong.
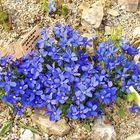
[0,121,13,136]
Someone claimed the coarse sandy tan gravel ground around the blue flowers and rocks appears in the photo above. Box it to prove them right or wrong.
[0,0,140,140]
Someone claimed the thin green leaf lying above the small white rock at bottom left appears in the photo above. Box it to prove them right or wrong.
[19,122,42,135]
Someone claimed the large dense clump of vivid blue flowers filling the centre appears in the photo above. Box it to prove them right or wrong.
[0,24,140,121]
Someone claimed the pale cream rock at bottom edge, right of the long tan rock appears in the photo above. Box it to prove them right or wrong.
[92,118,116,140]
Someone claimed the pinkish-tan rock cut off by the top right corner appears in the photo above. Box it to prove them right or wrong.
[118,0,139,12]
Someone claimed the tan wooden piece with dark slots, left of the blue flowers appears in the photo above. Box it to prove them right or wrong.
[0,25,41,59]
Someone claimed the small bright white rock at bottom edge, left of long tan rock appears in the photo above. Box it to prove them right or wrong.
[19,129,34,140]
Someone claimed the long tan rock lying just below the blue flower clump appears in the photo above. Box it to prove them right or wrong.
[31,113,70,137]
